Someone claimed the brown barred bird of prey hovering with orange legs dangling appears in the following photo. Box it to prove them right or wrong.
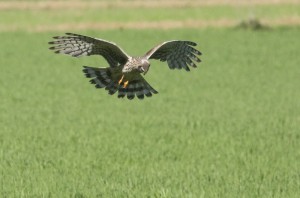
[49,33,201,100]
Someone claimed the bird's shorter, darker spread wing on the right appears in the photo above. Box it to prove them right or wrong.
[145,40,201,71]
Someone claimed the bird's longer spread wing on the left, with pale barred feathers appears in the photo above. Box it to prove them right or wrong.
[49,33,129,67]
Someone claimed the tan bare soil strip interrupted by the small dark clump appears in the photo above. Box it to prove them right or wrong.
[0,17,300,32]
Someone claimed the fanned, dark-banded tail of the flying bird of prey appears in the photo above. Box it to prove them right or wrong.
[83,66,158,100]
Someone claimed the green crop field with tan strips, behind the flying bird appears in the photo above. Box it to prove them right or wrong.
[0,0,300,198]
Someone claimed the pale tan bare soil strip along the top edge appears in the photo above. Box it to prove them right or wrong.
[0,0,300,10]
